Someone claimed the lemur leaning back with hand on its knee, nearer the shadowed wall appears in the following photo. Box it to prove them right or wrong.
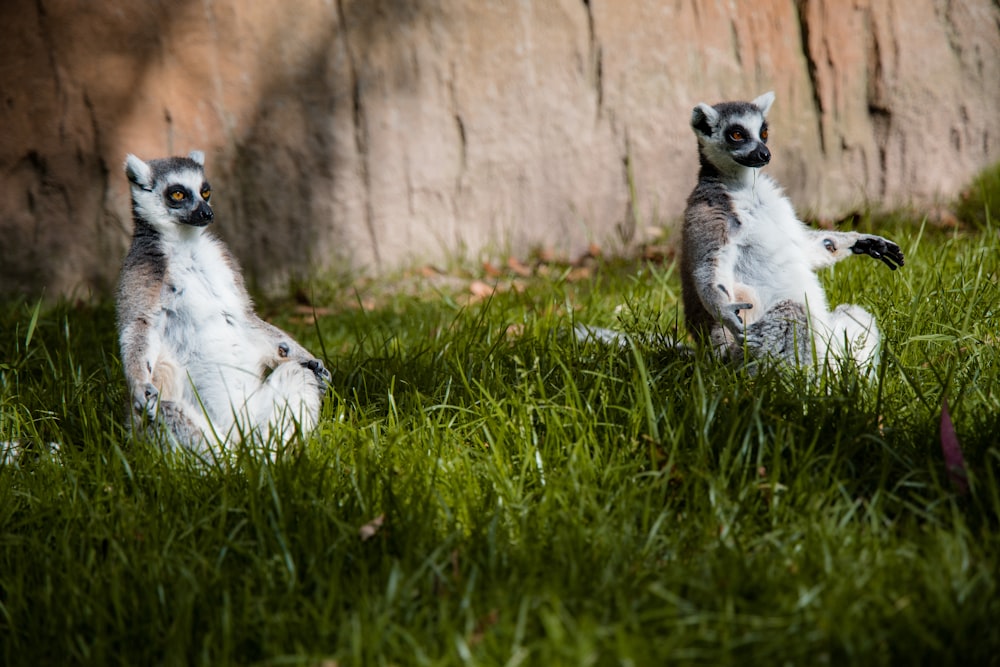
[118,151,330,453]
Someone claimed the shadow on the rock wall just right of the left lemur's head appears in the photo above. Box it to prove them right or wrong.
[225,0,439,290]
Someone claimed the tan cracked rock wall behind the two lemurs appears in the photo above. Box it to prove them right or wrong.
[0,0,1000,295]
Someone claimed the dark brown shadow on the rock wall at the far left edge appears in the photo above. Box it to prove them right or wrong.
[0,1,183,295]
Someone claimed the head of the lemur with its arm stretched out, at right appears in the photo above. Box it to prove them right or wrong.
[691,92,774,176]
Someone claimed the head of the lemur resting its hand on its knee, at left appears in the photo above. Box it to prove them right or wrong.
[125,151,214,231]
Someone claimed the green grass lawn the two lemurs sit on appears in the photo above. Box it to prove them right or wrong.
[0,221,1000,667]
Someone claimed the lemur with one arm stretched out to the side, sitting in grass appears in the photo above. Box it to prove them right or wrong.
[681,92,903,369]
